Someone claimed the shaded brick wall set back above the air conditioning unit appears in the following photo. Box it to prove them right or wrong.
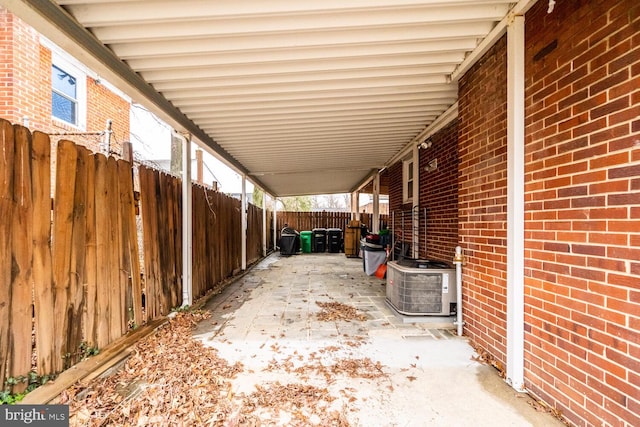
[419,120,458,262]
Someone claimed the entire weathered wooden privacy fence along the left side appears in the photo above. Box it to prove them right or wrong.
[0,119,272,393]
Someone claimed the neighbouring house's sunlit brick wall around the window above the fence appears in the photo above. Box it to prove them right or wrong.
[0,8,129,153]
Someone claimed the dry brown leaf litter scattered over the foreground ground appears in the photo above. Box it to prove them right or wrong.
[61,305,388,427]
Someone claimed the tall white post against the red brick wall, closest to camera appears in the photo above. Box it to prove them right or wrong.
[506,15,525,391]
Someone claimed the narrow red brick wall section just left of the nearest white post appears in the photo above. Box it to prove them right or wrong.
[458,37,507,372]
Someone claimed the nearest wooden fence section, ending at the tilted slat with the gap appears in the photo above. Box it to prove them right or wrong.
[0,119,142,392]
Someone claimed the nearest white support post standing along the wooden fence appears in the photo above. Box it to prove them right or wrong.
[181,134,193,307]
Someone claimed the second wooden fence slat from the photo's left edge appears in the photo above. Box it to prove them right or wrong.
[8,125,33,393]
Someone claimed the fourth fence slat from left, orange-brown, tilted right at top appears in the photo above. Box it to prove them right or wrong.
[52,141,78,372]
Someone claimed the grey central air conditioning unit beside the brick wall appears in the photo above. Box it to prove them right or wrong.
[386,259,457,316]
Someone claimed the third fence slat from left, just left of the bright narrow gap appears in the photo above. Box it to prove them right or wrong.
[32,132,54,375]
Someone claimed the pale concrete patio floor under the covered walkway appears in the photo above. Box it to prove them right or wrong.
[194,253,563,427]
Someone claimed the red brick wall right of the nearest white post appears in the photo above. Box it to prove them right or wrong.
[525,0,640,426]
